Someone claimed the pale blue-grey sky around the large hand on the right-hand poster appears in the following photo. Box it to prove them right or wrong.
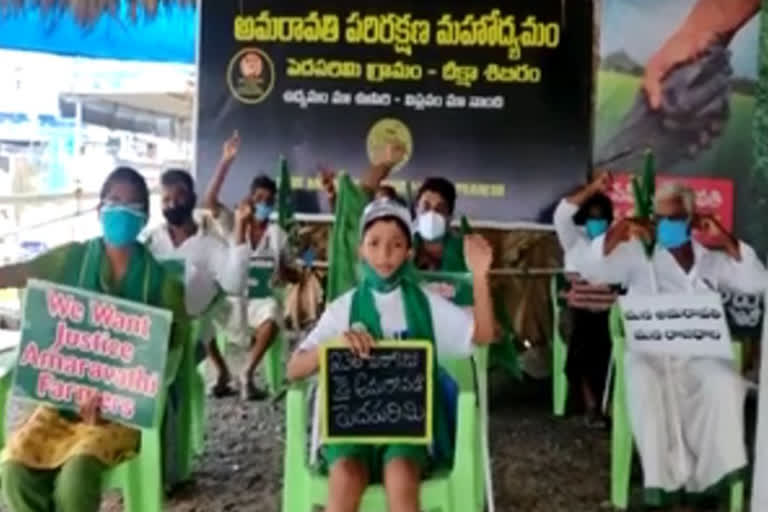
[600,0,760,80]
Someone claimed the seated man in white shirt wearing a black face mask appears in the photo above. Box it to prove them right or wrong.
[145,169,251,397]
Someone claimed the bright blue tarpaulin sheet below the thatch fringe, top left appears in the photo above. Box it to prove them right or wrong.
[0,2,197,64]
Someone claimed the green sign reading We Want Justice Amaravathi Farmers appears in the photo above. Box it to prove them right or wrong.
[13,280,172,428]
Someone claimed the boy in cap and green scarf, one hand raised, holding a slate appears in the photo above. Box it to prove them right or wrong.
[288,200,494,512]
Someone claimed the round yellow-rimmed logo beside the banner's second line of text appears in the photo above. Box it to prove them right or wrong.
[227,48,275,105]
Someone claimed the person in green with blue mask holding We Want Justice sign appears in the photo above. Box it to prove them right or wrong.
[0,167,188,512]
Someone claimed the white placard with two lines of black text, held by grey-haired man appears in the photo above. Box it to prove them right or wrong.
[619,293,733,360]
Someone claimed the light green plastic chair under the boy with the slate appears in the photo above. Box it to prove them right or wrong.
[282,359,485,512]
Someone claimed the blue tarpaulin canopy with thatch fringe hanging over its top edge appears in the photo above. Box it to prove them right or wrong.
[0,0,197,64]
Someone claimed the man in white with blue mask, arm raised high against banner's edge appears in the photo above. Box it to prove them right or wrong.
[205,132,287,400]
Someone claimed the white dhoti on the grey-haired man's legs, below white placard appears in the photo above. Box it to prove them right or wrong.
[626,353,747,493]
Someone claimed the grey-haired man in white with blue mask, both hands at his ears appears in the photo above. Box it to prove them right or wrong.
[582,183,766,507]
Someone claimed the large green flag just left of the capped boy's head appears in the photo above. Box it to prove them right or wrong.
[326,173,369,302]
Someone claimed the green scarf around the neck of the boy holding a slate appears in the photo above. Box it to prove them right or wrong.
[349,262,453,464]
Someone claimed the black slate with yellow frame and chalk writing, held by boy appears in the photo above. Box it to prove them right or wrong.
[320,341,434,445]
